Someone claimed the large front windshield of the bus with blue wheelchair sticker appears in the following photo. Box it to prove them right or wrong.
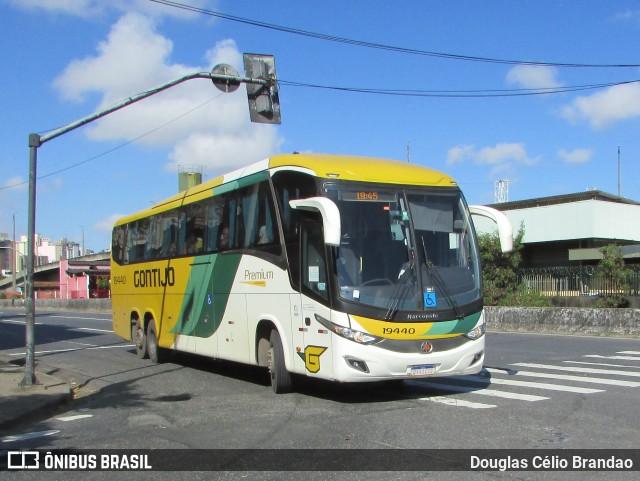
[325,183,481,320]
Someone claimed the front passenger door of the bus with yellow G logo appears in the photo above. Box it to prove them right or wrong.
[293,218,333,378]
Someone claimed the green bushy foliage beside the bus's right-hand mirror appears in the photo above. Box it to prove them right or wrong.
[478,224,550,306]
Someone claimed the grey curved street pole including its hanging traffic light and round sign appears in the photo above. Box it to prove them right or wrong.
[20,54,280,386]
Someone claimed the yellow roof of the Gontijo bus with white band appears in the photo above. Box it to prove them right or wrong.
[117,153,457,224]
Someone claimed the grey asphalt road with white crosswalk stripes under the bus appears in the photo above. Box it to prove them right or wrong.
[0,310,640,479]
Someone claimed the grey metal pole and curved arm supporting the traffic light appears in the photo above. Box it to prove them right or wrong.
[20,62,279,386]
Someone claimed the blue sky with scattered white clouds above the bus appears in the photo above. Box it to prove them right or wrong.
[0,0,640,251]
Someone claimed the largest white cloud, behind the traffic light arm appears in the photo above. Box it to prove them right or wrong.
[54,13,282,177]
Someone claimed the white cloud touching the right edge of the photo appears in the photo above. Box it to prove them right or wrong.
[561,83,640,129]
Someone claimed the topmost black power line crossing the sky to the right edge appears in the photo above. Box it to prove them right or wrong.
[149,0,640,68]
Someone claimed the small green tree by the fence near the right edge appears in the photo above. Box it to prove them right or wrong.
[596,244,631,307]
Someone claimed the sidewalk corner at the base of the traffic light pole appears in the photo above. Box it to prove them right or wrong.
[0,357,73,431]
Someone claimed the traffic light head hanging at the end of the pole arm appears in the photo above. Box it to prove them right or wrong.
[243,53,280,124]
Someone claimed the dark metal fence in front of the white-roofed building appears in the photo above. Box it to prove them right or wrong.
[518,265,640,297]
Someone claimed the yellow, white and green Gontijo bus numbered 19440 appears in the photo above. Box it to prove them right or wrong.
[111,153,512,393]
